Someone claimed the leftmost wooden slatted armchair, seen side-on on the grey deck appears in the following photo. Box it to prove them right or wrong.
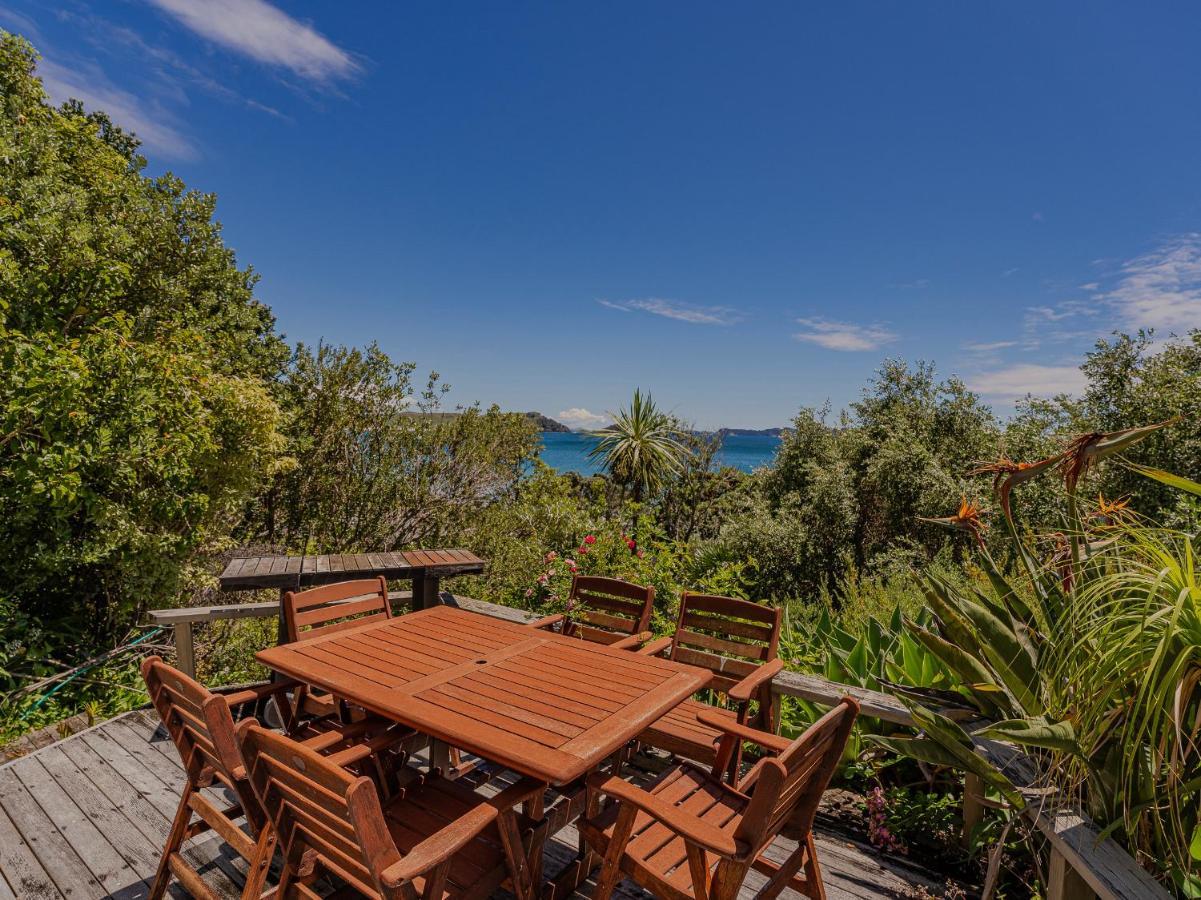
[142,656,413,900]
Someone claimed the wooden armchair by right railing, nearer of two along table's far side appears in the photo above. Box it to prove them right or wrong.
[638,591,783,768]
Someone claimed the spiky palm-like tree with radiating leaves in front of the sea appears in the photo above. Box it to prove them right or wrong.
[588,389,687,500]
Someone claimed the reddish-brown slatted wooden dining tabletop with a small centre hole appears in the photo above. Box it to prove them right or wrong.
[257,606,711,786]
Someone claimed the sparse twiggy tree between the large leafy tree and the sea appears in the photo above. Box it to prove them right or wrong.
[251,345,536,553]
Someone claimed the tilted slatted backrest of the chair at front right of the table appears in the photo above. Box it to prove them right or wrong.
[735,697,859,847]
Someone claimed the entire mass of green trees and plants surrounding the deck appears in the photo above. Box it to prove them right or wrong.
[7,35,1201,896]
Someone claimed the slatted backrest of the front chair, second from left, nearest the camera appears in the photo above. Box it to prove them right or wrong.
[239,722,400,895]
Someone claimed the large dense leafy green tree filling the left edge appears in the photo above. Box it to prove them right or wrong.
[0,32,285,655]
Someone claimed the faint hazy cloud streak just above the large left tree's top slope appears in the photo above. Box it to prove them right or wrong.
[37,59,199,160]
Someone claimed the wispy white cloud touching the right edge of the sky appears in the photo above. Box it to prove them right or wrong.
[1100,233,1201,333]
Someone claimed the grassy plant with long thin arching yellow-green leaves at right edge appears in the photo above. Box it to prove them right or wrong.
[1053,524,1201,886]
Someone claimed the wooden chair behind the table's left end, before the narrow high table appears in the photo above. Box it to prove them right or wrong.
[283,576,392,719]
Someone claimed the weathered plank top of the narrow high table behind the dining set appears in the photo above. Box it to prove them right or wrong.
[220,549,484,590]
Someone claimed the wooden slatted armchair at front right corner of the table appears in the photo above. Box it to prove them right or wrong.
[580,697,859,900]
